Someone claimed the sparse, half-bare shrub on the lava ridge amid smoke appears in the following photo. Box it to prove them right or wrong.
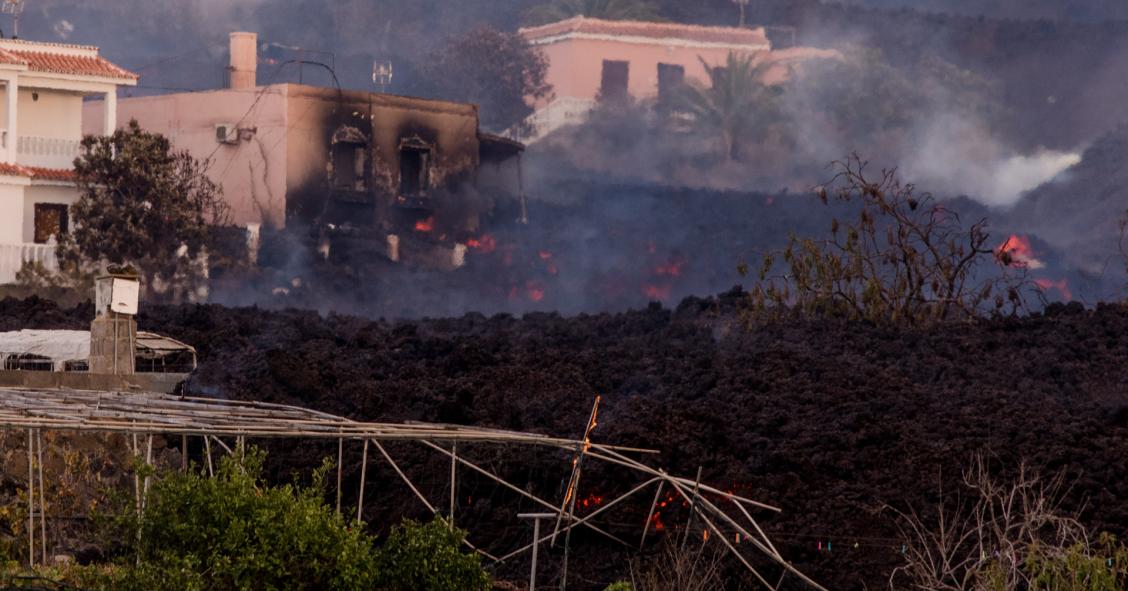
[739,156,1022,326]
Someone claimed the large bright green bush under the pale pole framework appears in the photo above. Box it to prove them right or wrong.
[112,450,376,590]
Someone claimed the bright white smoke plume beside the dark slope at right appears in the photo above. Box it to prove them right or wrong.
[901,115,1081,208]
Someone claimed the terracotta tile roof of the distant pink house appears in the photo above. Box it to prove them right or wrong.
[521,16,768,45]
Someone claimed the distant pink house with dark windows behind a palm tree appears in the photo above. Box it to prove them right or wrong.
[520,16,838,140]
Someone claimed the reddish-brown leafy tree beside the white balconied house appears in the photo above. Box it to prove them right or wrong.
[58,121,227,299]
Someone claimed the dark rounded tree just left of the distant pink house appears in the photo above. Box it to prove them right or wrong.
[418,26,553,131]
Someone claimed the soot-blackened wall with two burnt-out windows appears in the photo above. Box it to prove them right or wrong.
[280,85,479,230]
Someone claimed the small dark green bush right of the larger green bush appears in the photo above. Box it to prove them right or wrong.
[377,515,490,591]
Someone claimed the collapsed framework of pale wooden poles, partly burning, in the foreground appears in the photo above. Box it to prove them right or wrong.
[0,388,826,591]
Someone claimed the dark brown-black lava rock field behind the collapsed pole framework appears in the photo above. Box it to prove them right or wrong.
[0,293,1128,589]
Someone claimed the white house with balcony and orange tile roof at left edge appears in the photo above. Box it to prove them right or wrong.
[0,39,138,283]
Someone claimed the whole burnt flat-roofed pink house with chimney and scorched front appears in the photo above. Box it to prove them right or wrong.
[83,33,523,265]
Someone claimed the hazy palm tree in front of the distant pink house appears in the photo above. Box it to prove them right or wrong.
[681,52,783,160]
